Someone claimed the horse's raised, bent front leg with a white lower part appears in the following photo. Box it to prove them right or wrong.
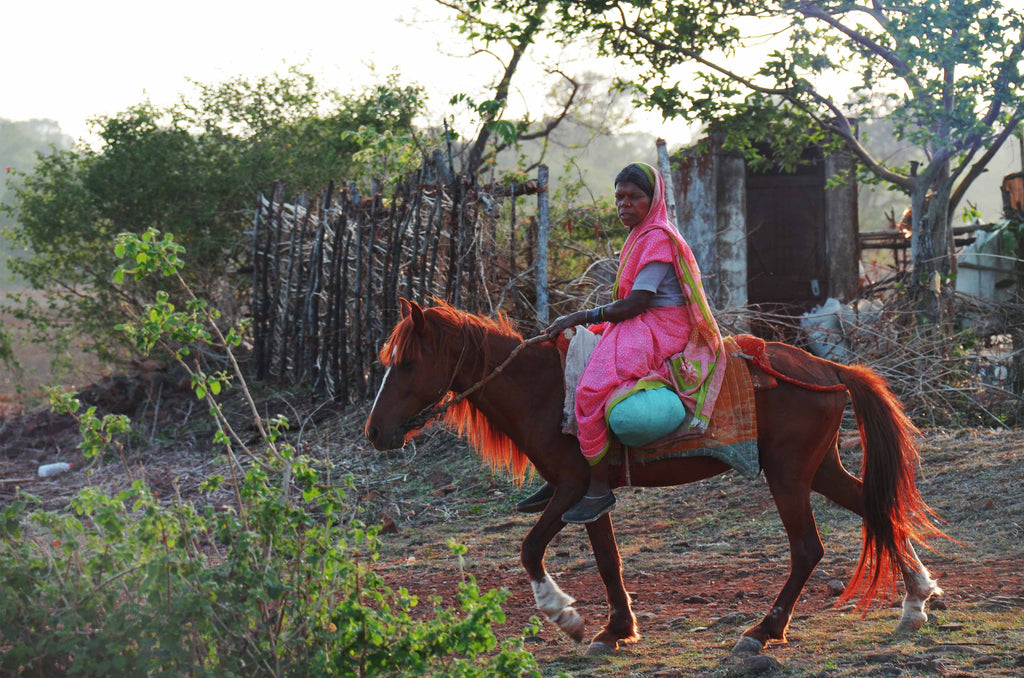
[520,490,584,642]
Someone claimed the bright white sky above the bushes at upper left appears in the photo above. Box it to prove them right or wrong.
[0,0,687,147]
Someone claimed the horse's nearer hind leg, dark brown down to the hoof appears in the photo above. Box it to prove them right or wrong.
[732,469,824,655]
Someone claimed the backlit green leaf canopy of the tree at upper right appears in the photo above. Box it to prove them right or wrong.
[552,0,1024,168]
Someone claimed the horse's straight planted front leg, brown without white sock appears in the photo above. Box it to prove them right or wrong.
[587,513,640,655]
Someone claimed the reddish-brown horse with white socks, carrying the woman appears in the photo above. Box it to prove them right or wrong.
[366,299,943,654]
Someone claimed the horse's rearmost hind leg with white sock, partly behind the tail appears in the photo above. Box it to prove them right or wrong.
[812,447,942,633]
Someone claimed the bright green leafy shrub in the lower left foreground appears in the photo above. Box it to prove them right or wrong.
[0,231,541,678]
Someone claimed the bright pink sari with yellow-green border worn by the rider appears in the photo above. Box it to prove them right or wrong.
[575,166,726,464]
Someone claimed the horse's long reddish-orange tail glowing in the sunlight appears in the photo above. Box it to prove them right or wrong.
[837,366,948,608]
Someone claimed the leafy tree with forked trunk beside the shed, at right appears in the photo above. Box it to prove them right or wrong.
[524,0,1024,307]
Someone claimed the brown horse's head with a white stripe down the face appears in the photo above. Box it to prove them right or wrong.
[364,299,453,450]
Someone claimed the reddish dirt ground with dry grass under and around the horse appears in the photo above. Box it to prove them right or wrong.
[0,376,1024,678]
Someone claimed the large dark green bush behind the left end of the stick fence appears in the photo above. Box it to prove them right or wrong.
[4,70,423,366]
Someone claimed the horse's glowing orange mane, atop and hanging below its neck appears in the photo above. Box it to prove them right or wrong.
[380,298,529,482]
